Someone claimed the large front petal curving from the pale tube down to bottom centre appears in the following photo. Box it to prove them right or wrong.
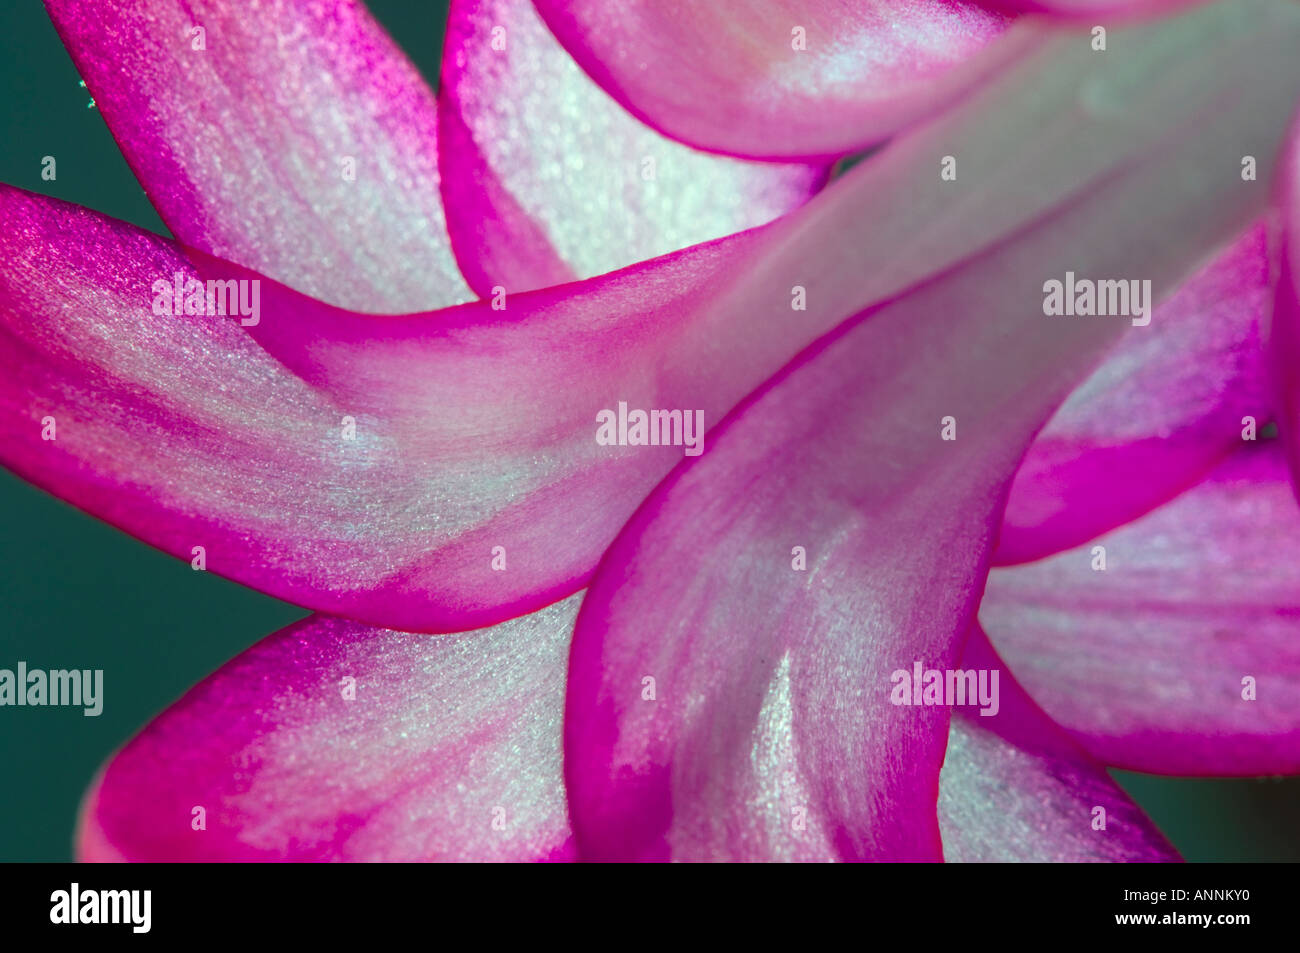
[566,3,1295,859]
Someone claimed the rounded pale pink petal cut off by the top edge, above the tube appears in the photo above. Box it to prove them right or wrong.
[536,0,1027,159]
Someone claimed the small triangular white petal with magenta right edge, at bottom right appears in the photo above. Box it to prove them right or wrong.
[939,625,1180,863]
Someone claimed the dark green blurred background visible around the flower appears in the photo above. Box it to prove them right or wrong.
[0,0,1300,861]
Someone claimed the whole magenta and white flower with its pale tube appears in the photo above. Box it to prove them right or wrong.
[0,0,1300,861]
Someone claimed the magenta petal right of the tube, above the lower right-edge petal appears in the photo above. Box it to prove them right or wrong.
[995,224,1274,564]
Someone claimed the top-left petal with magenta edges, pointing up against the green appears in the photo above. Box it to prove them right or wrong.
[47,0,472,312]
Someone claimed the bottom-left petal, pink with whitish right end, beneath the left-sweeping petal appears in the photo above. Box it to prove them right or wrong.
[78,595,581,862]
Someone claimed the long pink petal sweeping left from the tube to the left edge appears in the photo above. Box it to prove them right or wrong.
[0,189,878,631]
